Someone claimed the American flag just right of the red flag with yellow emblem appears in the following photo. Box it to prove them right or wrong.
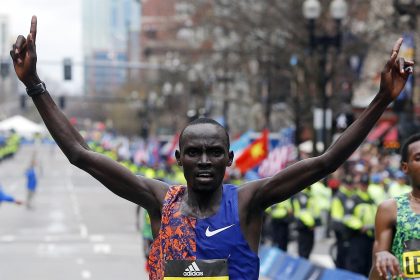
[258,128,297,178]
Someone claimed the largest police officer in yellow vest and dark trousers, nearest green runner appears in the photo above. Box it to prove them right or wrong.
[344,174,377,276]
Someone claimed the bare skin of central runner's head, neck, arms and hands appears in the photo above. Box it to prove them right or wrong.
[10,16,414,255]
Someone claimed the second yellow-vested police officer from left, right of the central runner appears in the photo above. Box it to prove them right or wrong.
[292,187,321,259]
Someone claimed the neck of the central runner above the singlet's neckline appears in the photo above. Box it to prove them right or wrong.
[181,185,223,218]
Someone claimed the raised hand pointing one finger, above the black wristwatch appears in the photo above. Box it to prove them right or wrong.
[10,16,41,87]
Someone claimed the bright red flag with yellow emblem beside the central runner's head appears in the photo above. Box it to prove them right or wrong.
[235,129,269,174]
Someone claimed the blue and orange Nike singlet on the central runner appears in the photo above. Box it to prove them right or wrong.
[149,185,259,280]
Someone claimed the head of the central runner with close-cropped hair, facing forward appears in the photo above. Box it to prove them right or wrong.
[175,124,233,192]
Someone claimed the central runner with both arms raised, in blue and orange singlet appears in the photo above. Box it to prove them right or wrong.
[10,16,414,280]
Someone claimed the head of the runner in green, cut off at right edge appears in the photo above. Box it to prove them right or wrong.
[401,133,420,187]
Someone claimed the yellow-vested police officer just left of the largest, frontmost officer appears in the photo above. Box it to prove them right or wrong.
[331,175,355,269]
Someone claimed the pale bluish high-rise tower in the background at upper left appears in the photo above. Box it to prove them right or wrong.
[82,0,140,95]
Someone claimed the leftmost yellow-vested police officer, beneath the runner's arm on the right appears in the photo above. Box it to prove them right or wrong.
[267,198,293,252]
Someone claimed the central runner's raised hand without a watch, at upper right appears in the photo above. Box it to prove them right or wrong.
[379,38,414,102]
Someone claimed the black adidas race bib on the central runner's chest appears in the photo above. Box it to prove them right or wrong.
[163,259,229,280]
